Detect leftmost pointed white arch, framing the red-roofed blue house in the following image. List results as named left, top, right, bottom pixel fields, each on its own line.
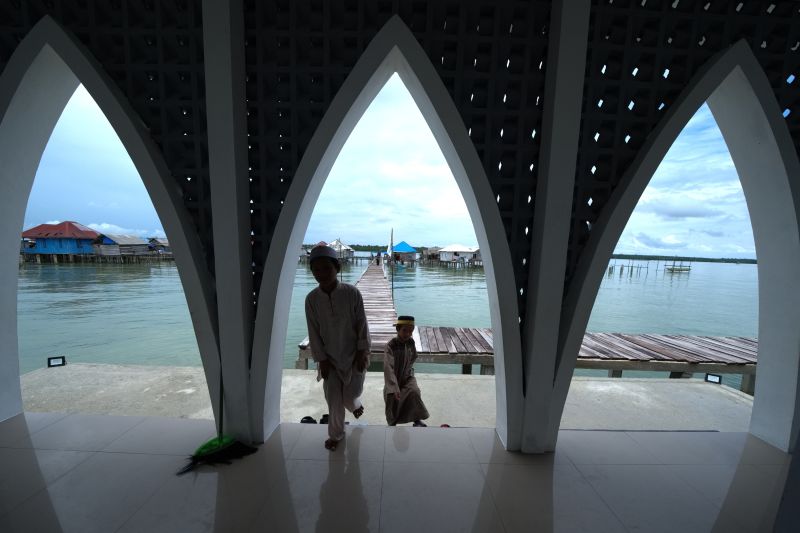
left=0, top=16, right=219, bottom=420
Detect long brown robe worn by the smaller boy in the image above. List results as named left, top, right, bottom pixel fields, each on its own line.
left=383, top=337, right=429, bottom=426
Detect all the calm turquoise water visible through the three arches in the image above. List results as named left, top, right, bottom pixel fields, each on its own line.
left=18, top=263, right=758, bottom=374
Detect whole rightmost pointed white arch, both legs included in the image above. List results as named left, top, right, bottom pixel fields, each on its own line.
left=549, top=41, right=800, bottom=450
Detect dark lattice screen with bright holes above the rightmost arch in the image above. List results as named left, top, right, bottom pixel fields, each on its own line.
left=567, top=0, right=800, bottom=283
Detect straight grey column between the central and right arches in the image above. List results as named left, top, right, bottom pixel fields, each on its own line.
left=522, top=0, right=590, bottom=453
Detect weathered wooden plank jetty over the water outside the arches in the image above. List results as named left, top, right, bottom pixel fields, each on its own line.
left=295, top=265, right=758, bottom=394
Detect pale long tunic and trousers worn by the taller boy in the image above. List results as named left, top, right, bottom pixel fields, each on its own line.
left=306, top=282, right=369, bottom=440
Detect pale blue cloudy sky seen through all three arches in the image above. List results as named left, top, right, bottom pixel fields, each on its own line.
left=24, top=75, right=755, bottom=257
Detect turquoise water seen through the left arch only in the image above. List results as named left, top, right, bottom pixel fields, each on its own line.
left=17, top=263, right=200, bottom=373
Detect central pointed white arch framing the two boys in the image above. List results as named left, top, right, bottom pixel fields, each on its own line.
left=251, top=16, right=522, bottom=449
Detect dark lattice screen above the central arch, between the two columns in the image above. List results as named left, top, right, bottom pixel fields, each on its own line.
left=245, top=0, right=550, bottom=324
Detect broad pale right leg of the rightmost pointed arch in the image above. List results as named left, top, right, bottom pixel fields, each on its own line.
left=708, top=64, right=800, bottom=451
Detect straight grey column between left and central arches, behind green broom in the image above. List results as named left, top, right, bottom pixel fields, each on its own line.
left=203, top=0, right=253, bottom=441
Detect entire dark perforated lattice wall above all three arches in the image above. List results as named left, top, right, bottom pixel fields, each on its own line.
left=9, top=0, right=800, bottom=336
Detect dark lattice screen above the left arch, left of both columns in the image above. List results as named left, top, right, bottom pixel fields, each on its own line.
left=0, top=0, right=214, bottom=272
